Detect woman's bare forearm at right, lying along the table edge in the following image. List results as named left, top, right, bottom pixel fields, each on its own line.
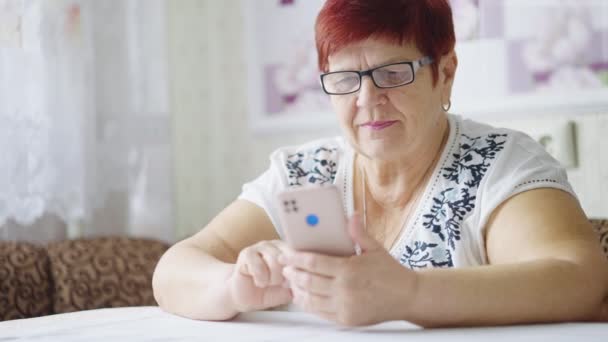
left=401, top=260, right=606, bottom=327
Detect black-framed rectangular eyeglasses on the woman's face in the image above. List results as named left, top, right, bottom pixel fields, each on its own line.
left=321, top=56, right=433, bottom=95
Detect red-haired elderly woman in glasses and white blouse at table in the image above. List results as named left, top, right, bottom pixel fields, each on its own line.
left=153, top=0, right=608, bottom=326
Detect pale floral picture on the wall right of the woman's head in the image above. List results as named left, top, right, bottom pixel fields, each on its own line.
left=451, top=0, right=608, bottom=117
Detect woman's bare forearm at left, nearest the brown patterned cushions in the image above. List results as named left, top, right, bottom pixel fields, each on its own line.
left=152, top=241, right=238, bottom=320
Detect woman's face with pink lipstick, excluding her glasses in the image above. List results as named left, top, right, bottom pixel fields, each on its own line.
left=329, top=39, right=457, bottom=160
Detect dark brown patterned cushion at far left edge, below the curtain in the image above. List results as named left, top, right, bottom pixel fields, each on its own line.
left=0, top=241, right=52, bottom=321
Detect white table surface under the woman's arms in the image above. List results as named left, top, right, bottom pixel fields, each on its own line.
left=0, top=307, right=608, bottom=342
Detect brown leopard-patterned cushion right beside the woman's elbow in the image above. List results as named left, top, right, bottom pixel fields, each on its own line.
left=47, top=237, right=168, bottom=313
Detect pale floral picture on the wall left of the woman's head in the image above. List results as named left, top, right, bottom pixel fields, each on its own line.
left=243, top=0, right=335, bottom=133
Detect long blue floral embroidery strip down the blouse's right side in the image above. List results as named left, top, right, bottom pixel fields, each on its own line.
left=400, top=134, right=507, bottom=268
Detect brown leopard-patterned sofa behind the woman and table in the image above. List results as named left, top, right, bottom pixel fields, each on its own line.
left=0, top=220, right=608, bottom=321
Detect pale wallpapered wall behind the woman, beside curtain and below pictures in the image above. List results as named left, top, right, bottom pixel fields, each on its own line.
left=167, top=0, right=608, bottom=237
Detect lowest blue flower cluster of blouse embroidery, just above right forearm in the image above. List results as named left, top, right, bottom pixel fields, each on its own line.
left=399, top=241, right=454, bottom=269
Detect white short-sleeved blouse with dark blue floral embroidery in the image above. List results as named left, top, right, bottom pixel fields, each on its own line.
left=239, top=115, right=576, bottom=269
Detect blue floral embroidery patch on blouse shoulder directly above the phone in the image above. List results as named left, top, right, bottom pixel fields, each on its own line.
left=286, top=147, right=338, bottom=186
